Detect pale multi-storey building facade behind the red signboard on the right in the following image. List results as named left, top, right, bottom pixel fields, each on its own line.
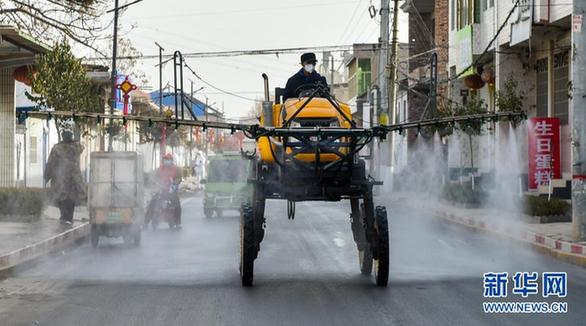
left=447, top=0, right=572, bottom=198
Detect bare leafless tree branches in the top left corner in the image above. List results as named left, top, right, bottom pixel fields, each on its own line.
left=0, top=0, right=110, bottom=56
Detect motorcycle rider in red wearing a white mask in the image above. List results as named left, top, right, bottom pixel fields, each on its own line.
left=145, top=153, right=181, bottom=228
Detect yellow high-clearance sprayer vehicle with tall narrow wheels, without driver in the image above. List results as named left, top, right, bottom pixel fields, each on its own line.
left=240, top=74, right=389, bottom=286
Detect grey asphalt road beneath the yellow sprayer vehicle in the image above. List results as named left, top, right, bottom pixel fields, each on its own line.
left=0, top=198, right=586, bottom=326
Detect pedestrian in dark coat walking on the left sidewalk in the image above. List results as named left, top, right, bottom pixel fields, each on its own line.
left=45, top=123, right=87, bottom=226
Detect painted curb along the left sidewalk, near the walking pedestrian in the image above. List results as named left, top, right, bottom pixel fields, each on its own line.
left=0, top=223, right=90, bottom=272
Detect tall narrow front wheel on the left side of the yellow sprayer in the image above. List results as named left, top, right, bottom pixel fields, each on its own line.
left=240, top=205, right=256, bottom=286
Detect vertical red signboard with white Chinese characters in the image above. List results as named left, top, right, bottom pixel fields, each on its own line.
left=528, top=118, right=562, bottom=189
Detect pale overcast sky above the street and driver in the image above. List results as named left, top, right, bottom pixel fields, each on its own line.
left=91, top=0, right=407, bottom=119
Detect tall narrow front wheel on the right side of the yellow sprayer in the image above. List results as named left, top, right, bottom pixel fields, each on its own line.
left=374, top=206, right=389, bottom=286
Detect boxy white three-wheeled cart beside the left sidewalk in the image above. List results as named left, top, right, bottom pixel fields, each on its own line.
left=88, top=152, right=144, bottom=248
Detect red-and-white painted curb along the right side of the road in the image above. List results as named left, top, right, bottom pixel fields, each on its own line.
left=435, top=211, right=586, bottom=267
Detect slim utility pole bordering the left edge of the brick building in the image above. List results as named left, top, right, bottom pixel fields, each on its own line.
left=387, top=0, right=399, bottom=166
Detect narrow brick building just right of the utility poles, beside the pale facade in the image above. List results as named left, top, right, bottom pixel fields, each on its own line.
left=393, top=0, right=449, bottom=173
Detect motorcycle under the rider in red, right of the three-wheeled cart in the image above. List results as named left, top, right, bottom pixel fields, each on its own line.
left=144, top=185, right=181, bottom=229
